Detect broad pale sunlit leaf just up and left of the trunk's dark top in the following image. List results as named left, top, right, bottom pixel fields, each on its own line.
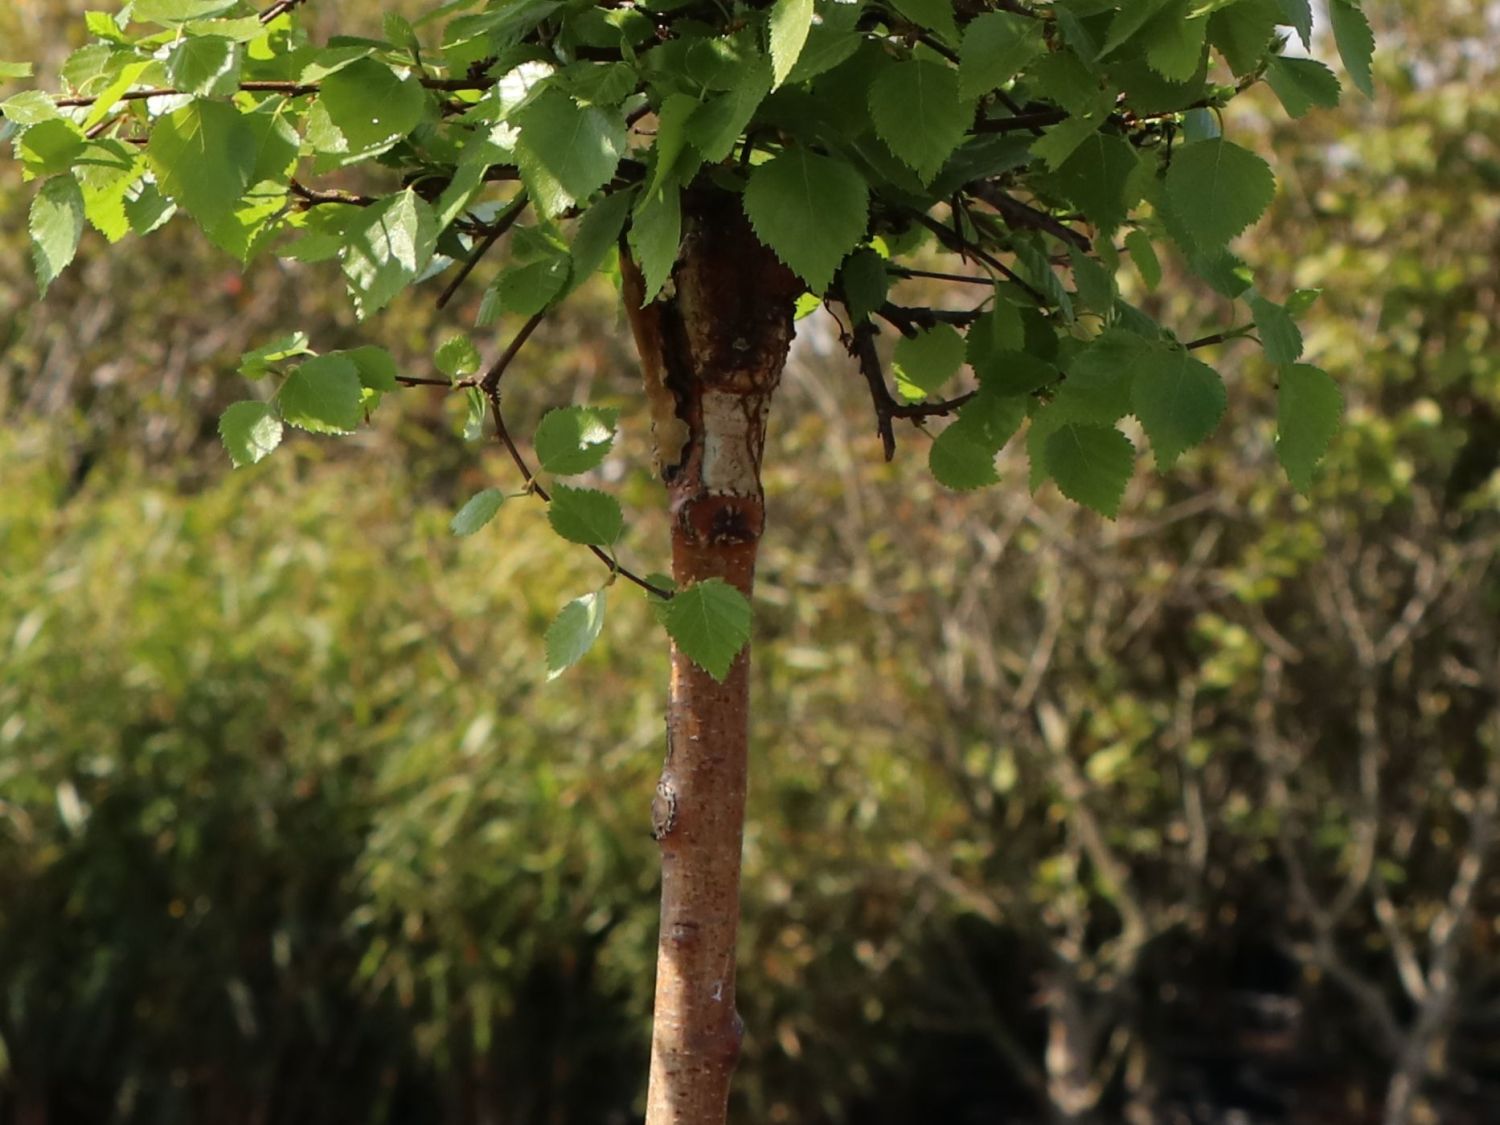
left=515, top=89, right=626, bottom=218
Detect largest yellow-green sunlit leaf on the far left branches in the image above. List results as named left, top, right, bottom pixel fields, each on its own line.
left=146, top=101, right=255, bottom=230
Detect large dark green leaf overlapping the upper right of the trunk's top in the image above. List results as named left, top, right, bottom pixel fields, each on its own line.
left=744, top=149, right=870, bottom=294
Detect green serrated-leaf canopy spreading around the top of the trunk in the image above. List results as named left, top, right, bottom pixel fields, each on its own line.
left=3, top=0, right=1371, bottom=669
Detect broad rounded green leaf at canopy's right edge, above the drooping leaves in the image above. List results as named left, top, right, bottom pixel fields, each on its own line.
left=1166, top=140, right=1277, bottom=249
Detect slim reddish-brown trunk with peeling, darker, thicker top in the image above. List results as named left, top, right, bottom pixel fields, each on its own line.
left=621, top=191, right=801, bottom=1125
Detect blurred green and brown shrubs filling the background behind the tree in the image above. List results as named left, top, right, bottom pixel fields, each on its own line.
left=0, top=0, right=1500, bottom=1125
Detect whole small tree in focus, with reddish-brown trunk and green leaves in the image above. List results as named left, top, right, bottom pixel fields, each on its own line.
left=0, top=0, right=1373, bottom=1125
